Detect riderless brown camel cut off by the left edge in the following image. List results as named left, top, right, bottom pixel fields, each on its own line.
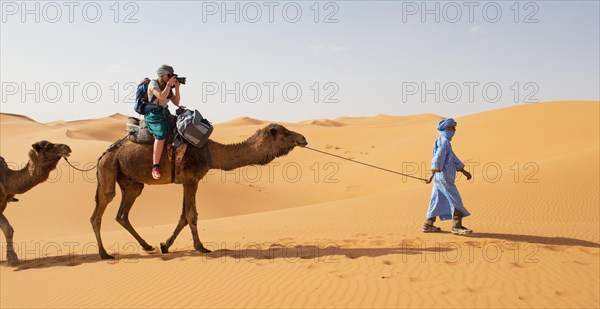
left=0, top=141, right=71, bottom=266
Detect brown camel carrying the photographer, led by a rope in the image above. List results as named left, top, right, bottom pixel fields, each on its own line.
left=90, top=124, right=308, bottom=259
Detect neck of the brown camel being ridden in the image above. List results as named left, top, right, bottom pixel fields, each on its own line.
left=208, top=140, right=275, bottom=171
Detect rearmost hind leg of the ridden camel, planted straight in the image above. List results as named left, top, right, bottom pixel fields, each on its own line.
left=90, top=157, right=117, bottom=259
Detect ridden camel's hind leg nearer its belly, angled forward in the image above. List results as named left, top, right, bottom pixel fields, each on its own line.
left=117, top=178, right=154, bottom=251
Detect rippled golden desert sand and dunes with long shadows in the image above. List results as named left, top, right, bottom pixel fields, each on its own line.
left=0, top=101, right=600, bottom=308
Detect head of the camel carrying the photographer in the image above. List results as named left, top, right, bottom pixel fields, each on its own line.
left=258, top=123, right=308, bottom=157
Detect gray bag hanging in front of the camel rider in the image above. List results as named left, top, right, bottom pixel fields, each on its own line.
left=177, top=109, right=213, bottom=148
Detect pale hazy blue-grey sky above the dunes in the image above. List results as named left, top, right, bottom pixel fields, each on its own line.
left=0, top=1, right=600, bottom=122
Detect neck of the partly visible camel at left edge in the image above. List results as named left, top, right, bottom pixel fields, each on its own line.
left=3, top=159, right=52, bottom=194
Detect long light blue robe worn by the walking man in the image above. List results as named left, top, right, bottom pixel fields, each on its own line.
left=427, top=132, right=470, bottom=220
